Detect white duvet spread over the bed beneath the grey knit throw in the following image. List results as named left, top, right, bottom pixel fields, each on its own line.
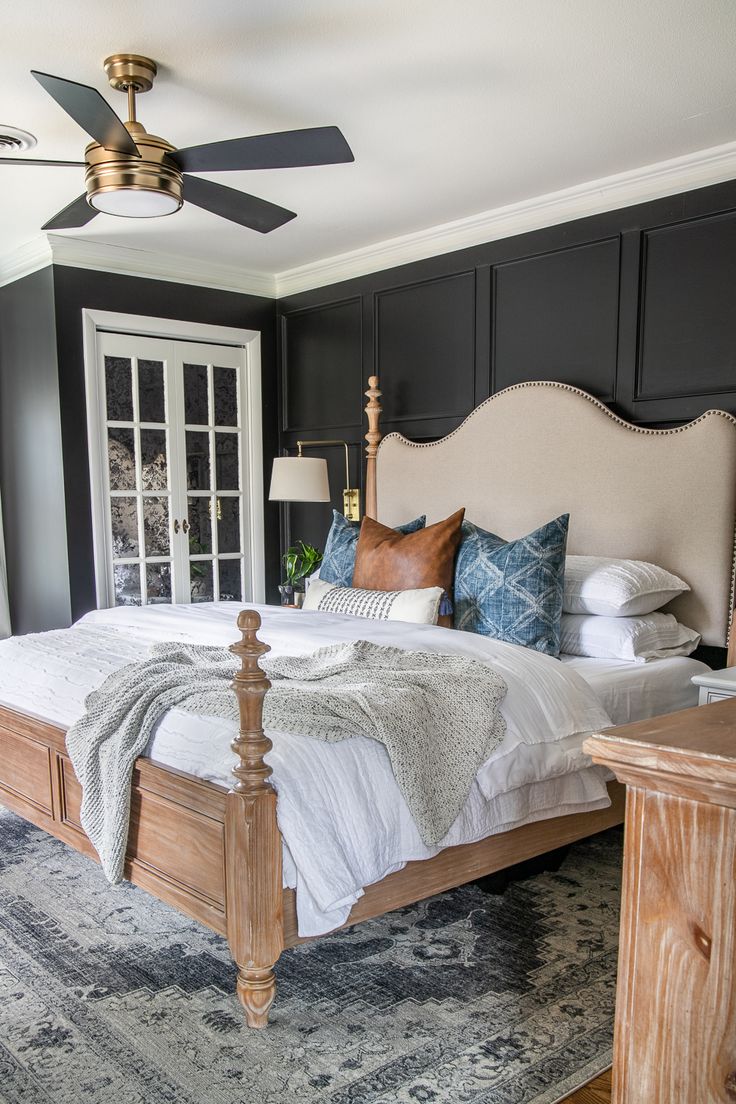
left=0, top=603, right=611, bottom=935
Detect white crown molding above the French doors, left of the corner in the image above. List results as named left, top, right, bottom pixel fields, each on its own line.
left=0, top=234, right=276, bottom=299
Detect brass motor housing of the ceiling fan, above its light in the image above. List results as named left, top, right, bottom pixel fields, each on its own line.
left=84, top=121, right=183, bottom=214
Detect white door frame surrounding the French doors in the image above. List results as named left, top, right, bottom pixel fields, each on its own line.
left=82, top=307, right=266, bottom=609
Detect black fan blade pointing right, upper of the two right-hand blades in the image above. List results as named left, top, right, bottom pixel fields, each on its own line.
left=174, top=127, right=355, bottom=172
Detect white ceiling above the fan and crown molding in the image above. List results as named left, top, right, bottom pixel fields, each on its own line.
left=0, top=0, right=736, bottom=293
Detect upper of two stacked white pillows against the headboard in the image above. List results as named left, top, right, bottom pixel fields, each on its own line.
left=563, top=555, right=690, bottom=617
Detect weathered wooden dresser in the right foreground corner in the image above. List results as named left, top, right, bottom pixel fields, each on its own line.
left=585, top=698, right=736, bottom=1104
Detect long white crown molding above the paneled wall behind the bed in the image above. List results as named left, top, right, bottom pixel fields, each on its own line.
left=276, top=142, right=736, bottom=298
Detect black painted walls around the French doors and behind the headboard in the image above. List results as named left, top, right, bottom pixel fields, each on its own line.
left=0, top=181, right=736, bottom=631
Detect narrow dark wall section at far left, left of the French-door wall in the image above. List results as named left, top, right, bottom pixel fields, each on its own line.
left=0, top=268, right=71, bottom=633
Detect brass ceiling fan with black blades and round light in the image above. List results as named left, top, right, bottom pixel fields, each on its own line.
left=0, top=54, right=355, bottom=234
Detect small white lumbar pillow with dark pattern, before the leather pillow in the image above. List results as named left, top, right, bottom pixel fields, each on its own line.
left=301, top=575, right=444, bottom=625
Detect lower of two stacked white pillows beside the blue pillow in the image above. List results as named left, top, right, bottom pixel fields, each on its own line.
left=559, top=614, right=701, bottom=664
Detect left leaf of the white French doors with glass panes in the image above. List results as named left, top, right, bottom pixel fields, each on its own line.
left=100, top=333, right=173, bottom=605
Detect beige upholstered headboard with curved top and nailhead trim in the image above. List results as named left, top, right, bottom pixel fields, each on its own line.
left=369, top=381, right=736, bottom=646
